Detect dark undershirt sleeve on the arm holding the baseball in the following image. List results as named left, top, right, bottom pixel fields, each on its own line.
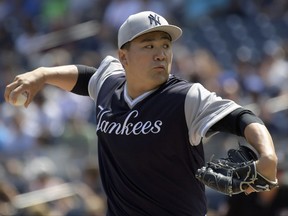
left=71, top=65, right=97, bottom=96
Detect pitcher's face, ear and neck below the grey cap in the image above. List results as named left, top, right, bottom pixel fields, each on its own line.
left=119, top=31, right=173, bottom=99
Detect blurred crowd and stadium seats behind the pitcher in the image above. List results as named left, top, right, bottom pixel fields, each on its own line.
left=0, top=0, right=288, bottom=216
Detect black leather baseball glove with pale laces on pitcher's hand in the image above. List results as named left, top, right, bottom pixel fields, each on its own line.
left=196, top=145, right=278, bottom=196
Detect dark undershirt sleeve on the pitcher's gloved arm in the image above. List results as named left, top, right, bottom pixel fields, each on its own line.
left=210, top=108, right=264, bottom=137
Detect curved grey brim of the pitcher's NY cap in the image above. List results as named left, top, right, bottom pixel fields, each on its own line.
left=130, top=25, right=182, bottom=41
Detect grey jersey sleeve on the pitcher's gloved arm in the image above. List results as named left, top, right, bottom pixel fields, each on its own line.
left=184, top=83, right=241, bottom=145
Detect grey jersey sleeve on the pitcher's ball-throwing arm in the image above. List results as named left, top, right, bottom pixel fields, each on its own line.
left=88, top=56, right=125, bottom=102
